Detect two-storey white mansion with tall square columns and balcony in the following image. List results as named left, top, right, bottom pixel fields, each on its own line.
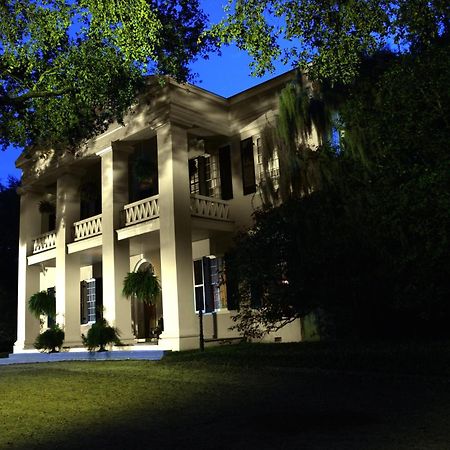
left=14, top=73, right=302, bottom=353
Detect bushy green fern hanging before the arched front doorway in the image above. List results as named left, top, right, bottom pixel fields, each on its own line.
left=122, top=265, right=161, bottom=304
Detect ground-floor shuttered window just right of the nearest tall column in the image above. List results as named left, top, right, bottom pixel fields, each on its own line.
left=194, top=256, right=227, bottom=313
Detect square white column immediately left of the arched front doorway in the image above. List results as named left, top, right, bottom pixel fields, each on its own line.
left=100, top=142, right=134, bottom=343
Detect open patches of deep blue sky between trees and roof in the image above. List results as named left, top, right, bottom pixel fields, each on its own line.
left=0, top=0, right=289, bottom=183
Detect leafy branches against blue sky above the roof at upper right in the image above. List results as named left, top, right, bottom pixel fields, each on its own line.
left=213, top=0, right=450, bottom=83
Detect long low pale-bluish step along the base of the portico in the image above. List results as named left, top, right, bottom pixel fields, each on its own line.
left=0, top=349, right=165, bottom=365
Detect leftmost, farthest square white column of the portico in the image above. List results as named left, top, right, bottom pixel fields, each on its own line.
left=14, top=192, right=41, bottom=353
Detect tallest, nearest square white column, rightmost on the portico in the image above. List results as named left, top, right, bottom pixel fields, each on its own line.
left=157, top=123, right=199, bottom=350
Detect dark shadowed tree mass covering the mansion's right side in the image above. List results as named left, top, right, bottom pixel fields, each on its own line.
left=228, top=38, right=450, bottom=337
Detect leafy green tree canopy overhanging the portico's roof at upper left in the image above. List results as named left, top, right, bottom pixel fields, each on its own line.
left=0, top=0, right=210, bottom=151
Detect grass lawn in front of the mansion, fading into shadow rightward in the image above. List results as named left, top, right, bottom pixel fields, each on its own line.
left=0, top=343, right=450, bottom=450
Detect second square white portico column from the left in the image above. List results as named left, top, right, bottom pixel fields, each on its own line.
left=55, top=174, right=82, bottom=347
